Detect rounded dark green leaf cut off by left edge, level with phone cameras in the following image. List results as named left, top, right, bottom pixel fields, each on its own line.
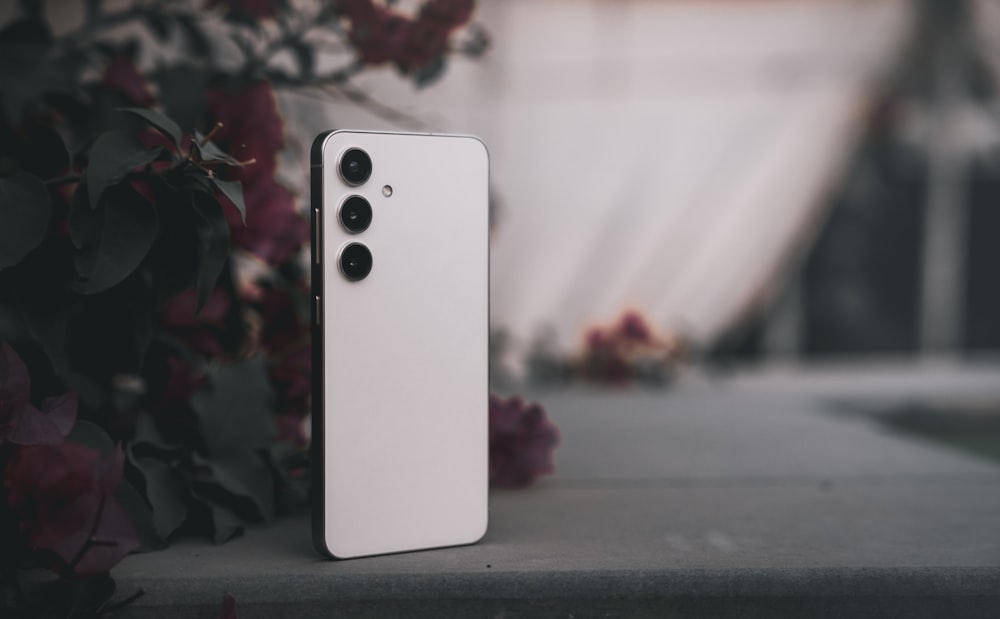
left=0, top=172, right=52, bottom=269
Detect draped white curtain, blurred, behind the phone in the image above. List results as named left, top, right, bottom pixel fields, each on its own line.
left=282, top=0, right=912, bottom=358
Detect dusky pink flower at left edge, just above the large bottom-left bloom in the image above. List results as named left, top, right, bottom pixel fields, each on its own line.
left=0, top=342, right=77, bottom=445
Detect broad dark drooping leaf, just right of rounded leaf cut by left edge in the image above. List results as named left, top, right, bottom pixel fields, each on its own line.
left=70, top=183, right=158, bottom=294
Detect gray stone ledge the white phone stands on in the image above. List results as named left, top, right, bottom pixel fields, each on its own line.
left=115, top=368, right=1000, bottom=619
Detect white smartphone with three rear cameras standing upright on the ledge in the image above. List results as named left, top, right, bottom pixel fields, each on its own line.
left=311, top=131, right=489, bottom=559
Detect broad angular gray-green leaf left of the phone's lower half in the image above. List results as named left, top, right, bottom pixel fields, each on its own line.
left=191, top=355, right=275, bottom=459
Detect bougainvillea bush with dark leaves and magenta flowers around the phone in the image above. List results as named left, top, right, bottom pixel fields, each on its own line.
left=0, top=0, right=554, bottom=617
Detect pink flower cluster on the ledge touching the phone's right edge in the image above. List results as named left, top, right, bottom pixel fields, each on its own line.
left=489, top=395, right=559, bottom=488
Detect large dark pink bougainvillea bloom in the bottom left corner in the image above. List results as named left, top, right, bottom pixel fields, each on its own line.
left=4, top=442, right=139, bottom=574
